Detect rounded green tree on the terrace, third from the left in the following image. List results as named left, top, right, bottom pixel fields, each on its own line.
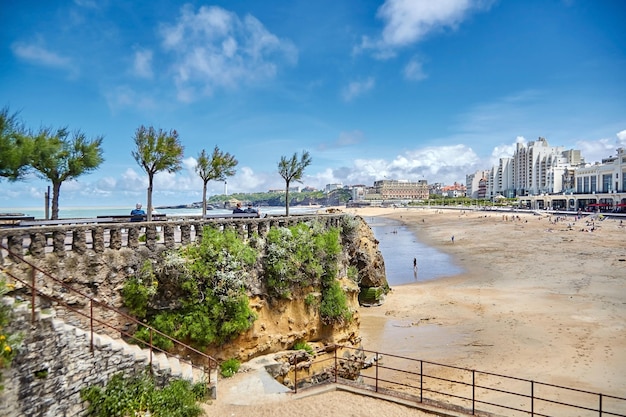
left=132, top=125, right=184, bottom=221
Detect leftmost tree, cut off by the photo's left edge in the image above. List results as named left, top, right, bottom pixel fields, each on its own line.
left=0, top=107, right=33, bottom=181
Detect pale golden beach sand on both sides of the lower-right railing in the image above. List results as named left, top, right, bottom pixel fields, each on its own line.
left=202, top=208, right=626, bottom=417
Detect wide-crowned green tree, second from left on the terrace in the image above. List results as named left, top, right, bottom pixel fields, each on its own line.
left=30, top=128, right=104, bottom=220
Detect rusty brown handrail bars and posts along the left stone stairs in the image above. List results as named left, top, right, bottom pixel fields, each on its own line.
left=0, top=244, right=218, bottom=383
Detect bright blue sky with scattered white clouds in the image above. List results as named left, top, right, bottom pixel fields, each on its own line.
left=0, top=0, right=626, bottom=208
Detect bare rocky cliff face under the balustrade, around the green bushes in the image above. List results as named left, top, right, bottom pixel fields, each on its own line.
left=4, top=217, right=388, bottom=361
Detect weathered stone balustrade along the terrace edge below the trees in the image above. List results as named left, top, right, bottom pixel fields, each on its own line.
left=0, top=214, right=345, bottom=261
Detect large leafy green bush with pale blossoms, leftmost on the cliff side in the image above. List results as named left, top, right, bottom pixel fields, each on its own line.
left=122, top=227, right=257, bottom=349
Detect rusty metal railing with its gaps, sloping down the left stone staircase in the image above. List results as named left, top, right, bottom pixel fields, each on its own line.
left=0, top=244, right=218, bottom=384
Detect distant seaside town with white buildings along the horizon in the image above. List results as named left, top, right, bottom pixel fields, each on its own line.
left=166, top=137, right=626, bottom=212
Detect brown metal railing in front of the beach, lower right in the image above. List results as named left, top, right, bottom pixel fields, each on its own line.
left=294, top=346, right=626, bottom=417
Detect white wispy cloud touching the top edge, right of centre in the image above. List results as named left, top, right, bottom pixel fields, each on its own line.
left=356, top=0, right=491, bottom=59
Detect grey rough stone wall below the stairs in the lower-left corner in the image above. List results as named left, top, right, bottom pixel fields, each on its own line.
left=0, top=298, right=193, bottom=417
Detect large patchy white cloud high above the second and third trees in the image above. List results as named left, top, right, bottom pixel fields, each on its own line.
left=160, top=5, right=298, bottom=102
